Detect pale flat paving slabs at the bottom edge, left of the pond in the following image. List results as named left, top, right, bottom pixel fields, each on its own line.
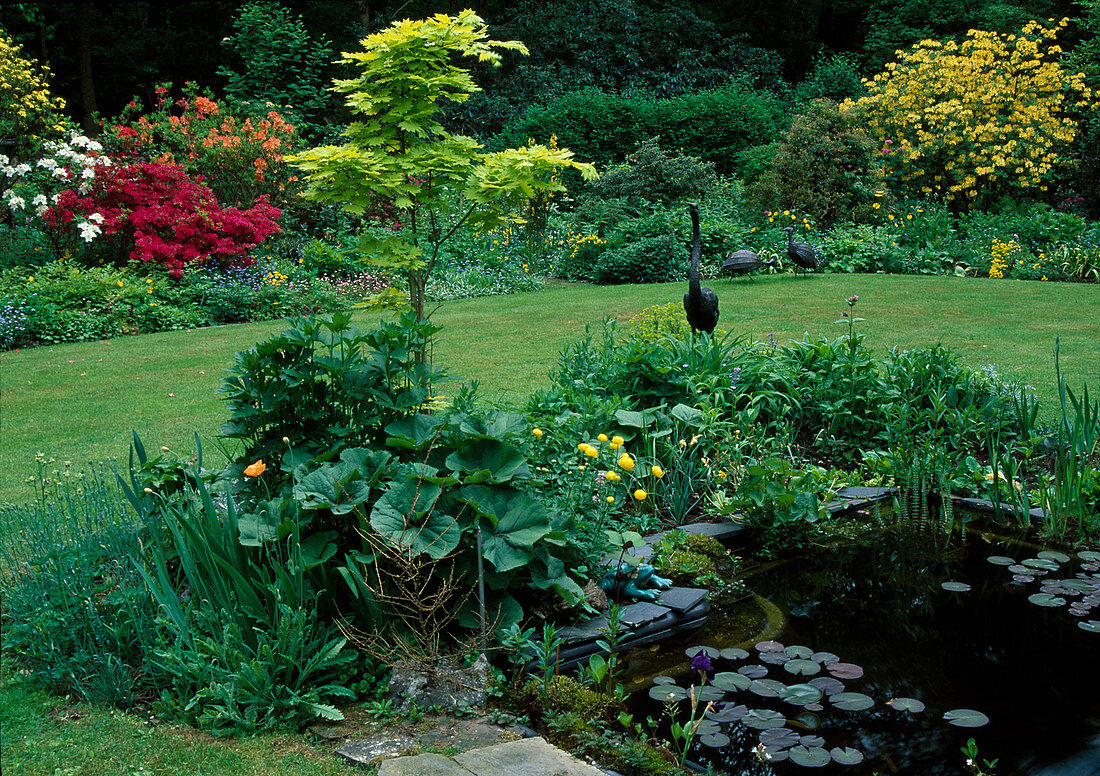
left=378, top=739, right=604, bottom=776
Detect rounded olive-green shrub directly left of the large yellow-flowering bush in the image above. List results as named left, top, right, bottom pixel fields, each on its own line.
left=746, top=100, right=889, bottom=225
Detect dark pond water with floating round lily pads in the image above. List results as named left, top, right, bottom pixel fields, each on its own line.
left=647, top=526, right=1100, bottom=776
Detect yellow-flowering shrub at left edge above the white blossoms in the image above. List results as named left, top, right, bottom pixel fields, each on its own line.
left=0, top=32, right=65, bottom=151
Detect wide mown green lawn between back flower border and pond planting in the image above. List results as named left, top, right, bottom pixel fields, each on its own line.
left=0, top=275, right=1100, bottom=502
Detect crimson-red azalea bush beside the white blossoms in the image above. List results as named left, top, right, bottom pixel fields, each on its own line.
left=43, top=162, right=282, bottom=278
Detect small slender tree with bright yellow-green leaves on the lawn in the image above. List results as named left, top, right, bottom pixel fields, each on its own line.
left=283, top=11, right=596, bottom=320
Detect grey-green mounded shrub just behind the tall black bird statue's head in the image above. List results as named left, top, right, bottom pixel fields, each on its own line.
left=590, top=138, right=717, bottom=207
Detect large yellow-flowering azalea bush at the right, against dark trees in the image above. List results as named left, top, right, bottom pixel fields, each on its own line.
left=843, top=19, right=1092, bottom=208
